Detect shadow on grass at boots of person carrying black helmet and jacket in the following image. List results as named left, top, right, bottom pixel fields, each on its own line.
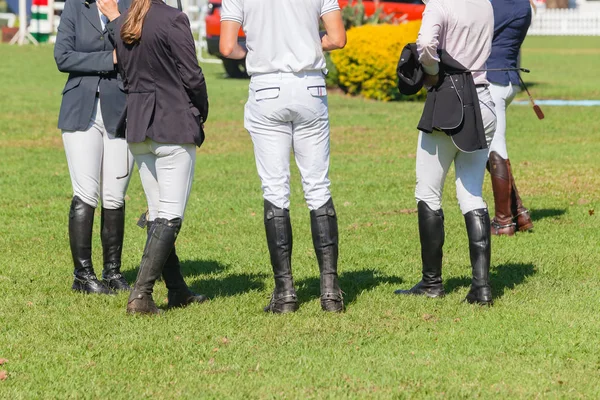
left=444, top=263, right=536, bottom=298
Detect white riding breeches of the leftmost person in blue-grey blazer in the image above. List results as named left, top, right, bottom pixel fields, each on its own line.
left=62, top=99, right=133, bottom=210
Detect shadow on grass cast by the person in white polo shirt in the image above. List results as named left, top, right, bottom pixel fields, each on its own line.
left=296, top=269, right=402, bottom=306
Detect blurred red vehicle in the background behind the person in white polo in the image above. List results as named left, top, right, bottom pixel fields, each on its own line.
left=206, top=0, right=425, bottom=78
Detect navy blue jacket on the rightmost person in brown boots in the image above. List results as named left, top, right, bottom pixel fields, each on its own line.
left=486, top=0, right=531, bottom=86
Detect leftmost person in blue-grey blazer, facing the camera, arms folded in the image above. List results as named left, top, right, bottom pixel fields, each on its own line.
left=54, top=0, right=133, bottom=294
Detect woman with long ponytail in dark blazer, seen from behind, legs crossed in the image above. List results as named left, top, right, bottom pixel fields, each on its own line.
left=103, top=0, right=208, bottom=314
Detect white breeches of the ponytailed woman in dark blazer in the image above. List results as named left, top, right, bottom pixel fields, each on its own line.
left=129, top=139, right=196, bottom=221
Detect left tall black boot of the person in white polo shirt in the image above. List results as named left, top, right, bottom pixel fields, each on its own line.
left=264, top=200, right=298, bottom=314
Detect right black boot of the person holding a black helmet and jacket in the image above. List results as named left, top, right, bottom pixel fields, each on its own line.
left=465, top=208, right=493, bottom=305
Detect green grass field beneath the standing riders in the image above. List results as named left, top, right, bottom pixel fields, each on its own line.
left=0, top=37, right=600, bottom=399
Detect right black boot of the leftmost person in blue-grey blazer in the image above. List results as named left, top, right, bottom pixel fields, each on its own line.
left=100, top=206, right=131, bottom=291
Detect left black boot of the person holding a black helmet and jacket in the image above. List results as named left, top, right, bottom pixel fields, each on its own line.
left=394, top=201, right=445, bottom=297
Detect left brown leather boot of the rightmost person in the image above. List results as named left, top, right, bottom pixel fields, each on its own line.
left=488, top=151, right=516, bottom=236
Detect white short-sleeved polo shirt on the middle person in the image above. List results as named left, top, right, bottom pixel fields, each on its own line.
left=221, top=0, right=340, bottom=75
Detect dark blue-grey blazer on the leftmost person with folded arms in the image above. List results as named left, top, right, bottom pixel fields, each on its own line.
left=54, top=0, right=131, bottom=134
